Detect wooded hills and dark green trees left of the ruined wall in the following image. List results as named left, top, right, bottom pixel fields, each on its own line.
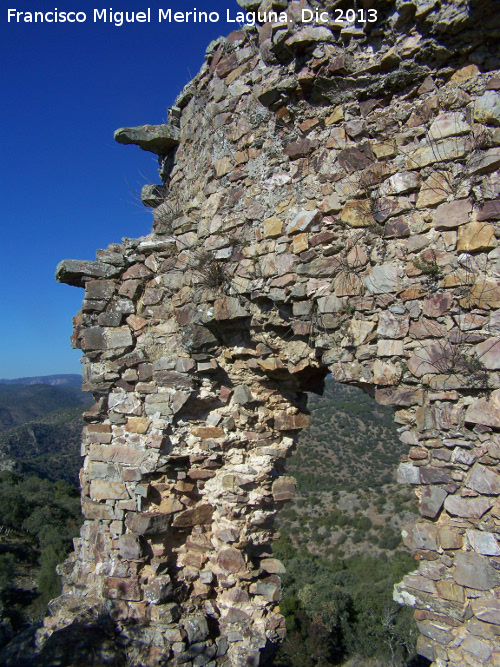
left=0, top=376, right=86, bottom=652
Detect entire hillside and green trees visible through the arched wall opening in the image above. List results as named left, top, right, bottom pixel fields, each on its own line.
left=271, top=379, right=422, bottom=667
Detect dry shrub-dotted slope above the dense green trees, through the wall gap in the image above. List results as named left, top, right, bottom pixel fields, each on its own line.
left=278, top=379, right=417, bottom=557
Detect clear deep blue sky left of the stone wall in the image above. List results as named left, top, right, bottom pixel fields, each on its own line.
left=0, top=0, right=241, bottom=378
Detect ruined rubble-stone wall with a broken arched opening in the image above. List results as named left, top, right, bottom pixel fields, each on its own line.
left=39, top=2, right=500, bottom=666
